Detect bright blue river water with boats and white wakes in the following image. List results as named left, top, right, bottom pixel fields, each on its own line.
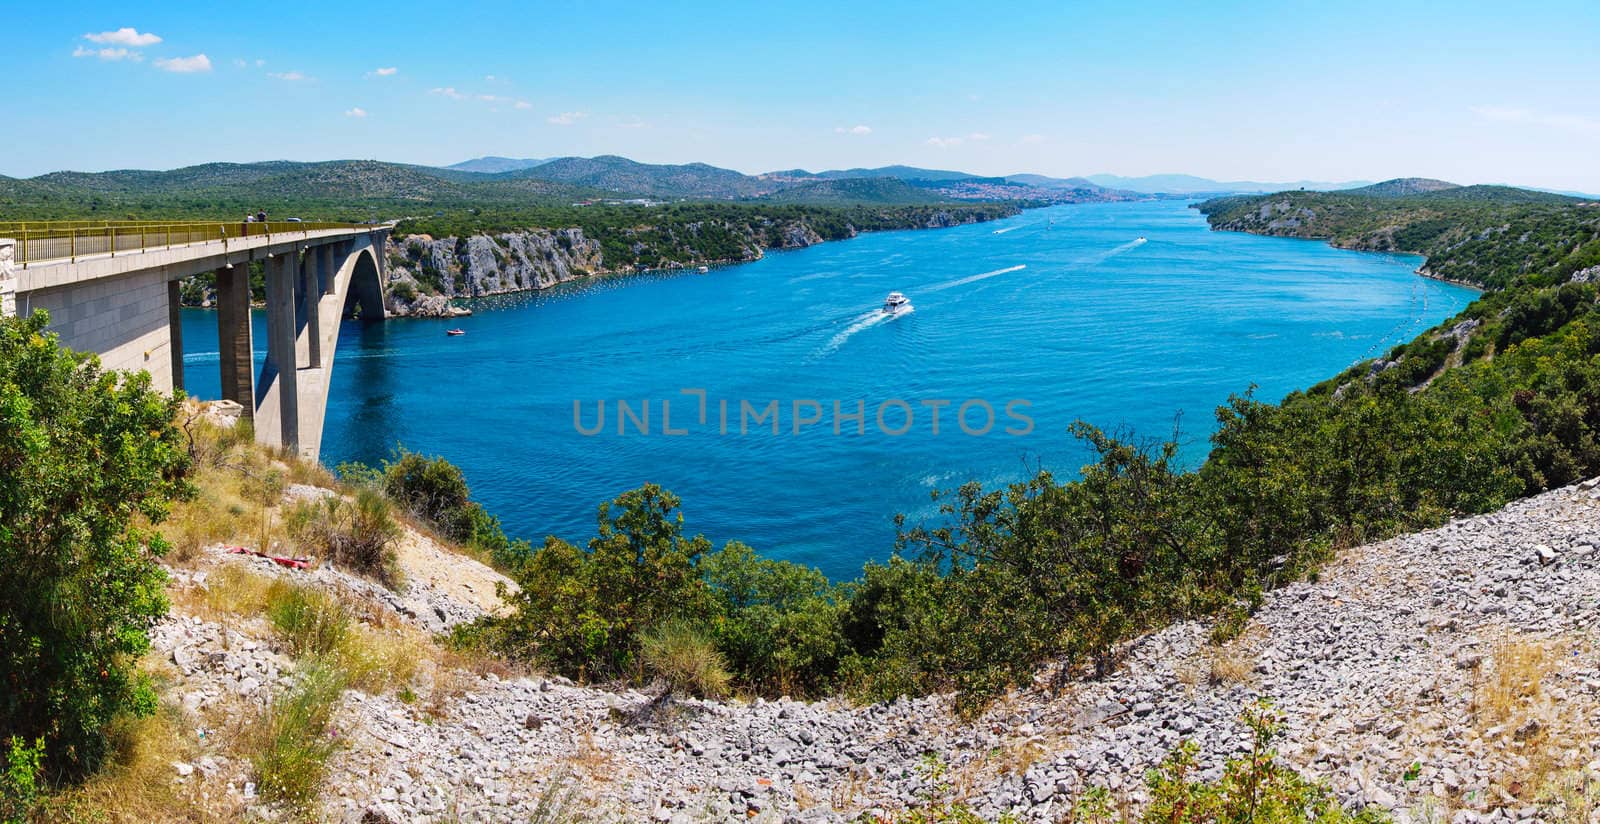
left=184, top=202, right=1475, bottom=579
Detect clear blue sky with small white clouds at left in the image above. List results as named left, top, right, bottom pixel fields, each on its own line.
left=9, top=0, right=1600, bottom=192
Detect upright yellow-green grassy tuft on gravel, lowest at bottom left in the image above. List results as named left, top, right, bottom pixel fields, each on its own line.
left=250, top=659, right=344, bottom=811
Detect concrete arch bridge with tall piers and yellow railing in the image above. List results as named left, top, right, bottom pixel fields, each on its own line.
left=0, top=221, right=394, bottom=459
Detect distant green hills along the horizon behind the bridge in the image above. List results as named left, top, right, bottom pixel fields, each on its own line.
left=0, top=155, right=1141, bottom=222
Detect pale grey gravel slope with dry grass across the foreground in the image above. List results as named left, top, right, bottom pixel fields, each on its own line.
left=157, top=482, right=1600, bottom=824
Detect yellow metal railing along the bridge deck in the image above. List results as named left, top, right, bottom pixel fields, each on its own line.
left=0, top=221, right=376, bottom=269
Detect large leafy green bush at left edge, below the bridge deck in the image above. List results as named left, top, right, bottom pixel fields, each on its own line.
left=0, top=312, right=190, bottom=778
